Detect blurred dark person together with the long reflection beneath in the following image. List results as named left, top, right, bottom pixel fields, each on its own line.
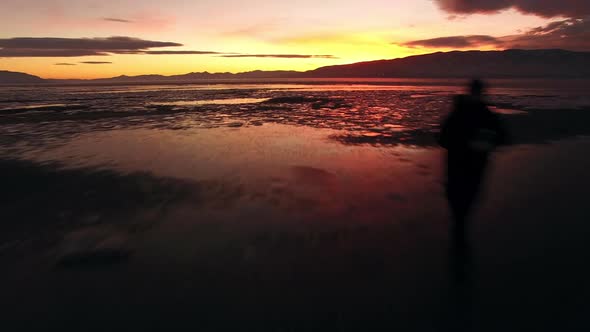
left=439, top=80, right=507, bottom=331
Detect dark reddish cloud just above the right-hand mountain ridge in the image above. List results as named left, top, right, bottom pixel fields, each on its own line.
left=400, top=18, right=590, bottom=51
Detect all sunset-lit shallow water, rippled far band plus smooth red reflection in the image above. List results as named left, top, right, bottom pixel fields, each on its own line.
left=0, top=81, right=590, bottom=231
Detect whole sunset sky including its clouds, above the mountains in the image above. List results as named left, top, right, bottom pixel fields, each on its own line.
left=0, top=0, right=590, bottom=79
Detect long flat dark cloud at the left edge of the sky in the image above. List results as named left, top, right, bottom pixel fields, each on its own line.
left=0, top=37, right=182, bottom=57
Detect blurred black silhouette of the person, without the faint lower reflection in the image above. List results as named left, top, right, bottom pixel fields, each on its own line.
left=439, top=80, right=506, bottom=255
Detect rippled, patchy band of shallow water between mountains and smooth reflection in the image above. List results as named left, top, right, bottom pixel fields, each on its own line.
left=0, top=80, right=590, bottom=158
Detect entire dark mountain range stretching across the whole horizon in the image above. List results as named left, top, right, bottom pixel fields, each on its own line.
left=0, top=49, right=590, bottom=84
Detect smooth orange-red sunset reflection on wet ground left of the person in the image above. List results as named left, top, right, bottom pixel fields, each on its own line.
left=19, top=124, right=442, bottom=227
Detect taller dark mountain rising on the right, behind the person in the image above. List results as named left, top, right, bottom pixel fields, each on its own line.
left=305, top=50, right=590, bottom=78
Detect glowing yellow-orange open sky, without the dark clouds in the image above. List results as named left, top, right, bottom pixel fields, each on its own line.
left=0, top=0, right=563, bottom=78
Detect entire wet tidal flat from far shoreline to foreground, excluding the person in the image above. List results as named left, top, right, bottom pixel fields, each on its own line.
left=0, top=80, right=590, bottom=331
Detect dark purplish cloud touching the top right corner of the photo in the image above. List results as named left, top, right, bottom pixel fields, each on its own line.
left=435, top=0, right=590, bottom=18
